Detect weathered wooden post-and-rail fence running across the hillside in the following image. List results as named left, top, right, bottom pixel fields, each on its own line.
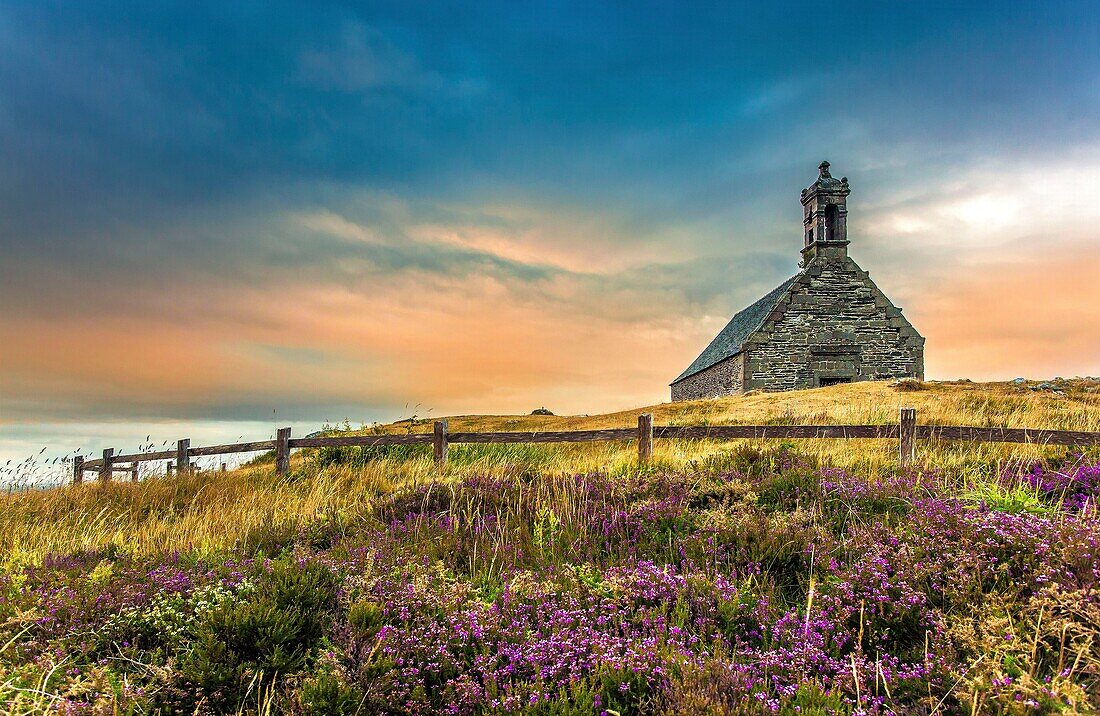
left=73, top=408, right=1100, bottom=483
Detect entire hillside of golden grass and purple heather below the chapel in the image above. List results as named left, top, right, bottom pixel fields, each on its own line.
left=0, top=381, right=1100, bottom=715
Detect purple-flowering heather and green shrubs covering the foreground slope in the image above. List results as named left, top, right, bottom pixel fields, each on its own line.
left=0, top=458, right=1100, bottom=715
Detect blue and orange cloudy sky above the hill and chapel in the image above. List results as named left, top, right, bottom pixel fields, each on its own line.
left=0, top=0, right=1100, bottom=475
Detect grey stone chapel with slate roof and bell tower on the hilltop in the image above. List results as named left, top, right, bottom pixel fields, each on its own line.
left=671, top=162, right=924, bottom=400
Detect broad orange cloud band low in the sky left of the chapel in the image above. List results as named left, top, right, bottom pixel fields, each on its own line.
left=0, top=265, right=699, bottom=415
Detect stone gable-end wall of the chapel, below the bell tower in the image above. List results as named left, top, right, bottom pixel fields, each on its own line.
left=743, top=257, right=924, bottom=391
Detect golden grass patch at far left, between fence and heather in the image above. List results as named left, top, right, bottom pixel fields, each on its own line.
left=0, top=464, right=393, bottom=563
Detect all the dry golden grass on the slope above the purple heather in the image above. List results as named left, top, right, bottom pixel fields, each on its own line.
left=0, top=382, right=1100, bottom=566
